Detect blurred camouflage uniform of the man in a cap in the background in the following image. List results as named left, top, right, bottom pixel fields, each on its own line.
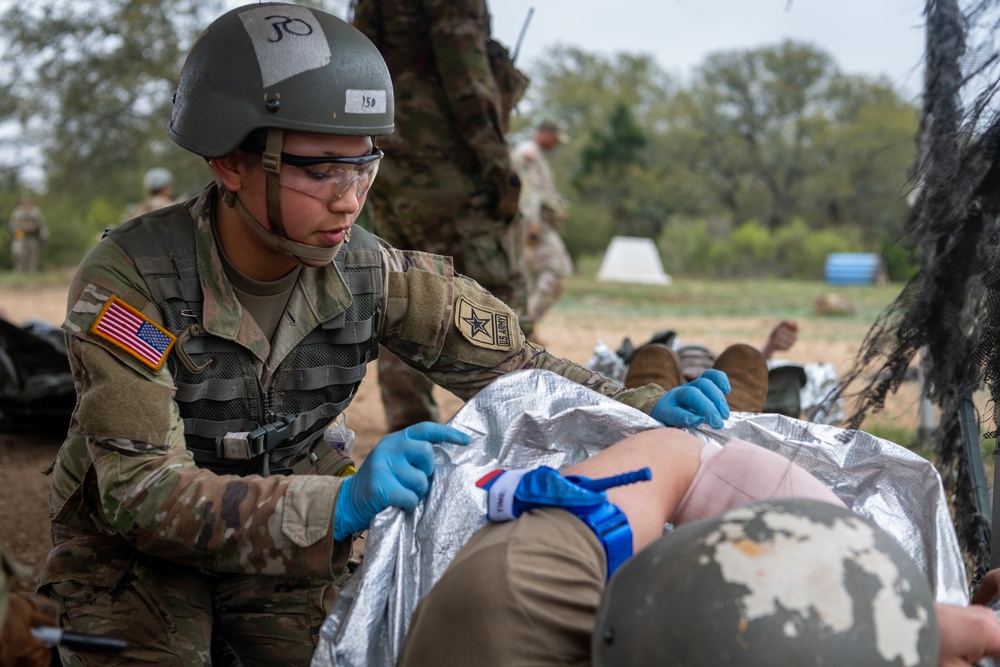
left=511, top=139, right=573, bottom=324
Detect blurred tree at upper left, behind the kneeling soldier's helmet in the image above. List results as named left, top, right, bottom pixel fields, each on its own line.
left=0, top=0, right=222, bottom=201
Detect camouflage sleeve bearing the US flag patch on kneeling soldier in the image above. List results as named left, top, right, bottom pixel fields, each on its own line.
left=60, top=240, right=350, bottom=577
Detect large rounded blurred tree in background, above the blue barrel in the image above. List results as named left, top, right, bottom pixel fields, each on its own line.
left=669, top=41, right=917, bottom=233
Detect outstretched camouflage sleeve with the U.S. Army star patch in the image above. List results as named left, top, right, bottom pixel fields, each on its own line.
left=380, top=247, right=665, bottom=414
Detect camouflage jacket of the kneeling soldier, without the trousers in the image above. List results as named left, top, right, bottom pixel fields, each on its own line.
left=40, top=186, right=662, bottom=583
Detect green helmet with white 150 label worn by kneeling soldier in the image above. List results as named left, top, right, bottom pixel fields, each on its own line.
left=169, top=3, right=393, bottom=158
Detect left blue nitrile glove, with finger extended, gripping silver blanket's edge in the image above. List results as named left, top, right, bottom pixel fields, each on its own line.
left=333, top=422, right=472, bottom=541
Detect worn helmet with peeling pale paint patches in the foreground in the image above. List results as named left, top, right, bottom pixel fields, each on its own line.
left=593, top=499, right=939, bottom=667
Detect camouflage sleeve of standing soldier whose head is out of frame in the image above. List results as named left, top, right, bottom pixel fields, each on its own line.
left=424, top=0, right=511, bottom=173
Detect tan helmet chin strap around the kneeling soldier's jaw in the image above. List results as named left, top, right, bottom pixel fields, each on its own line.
left=214, top=128, right=342, bottom=266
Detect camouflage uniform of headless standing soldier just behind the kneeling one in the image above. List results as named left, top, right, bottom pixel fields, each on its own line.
left=354, top=0, right=530, bottom=431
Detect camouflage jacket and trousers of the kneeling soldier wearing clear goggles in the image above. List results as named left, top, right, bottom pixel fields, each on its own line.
left=39, top=185, right=663, bottom=665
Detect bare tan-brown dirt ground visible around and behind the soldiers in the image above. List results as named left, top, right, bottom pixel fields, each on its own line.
left=0, top=276, right=916, bottom=589
